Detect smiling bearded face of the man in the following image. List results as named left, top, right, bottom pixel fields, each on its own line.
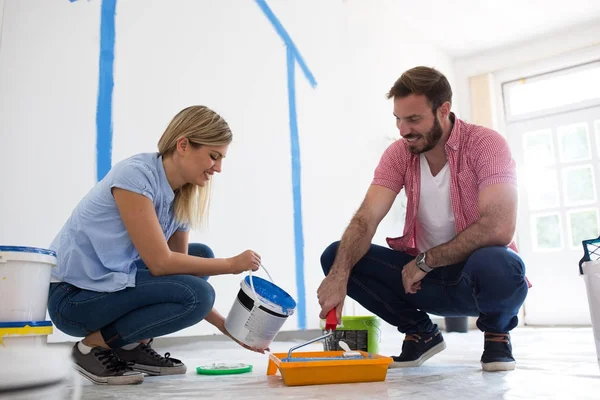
left=394, top=94, right=443, bottom=154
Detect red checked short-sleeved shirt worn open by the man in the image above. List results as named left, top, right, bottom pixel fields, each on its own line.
left=372, top=114, right=517, bottom=256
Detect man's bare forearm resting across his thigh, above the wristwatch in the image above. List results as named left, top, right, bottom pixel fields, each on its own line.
left=425, top=218, right=508, bottom=268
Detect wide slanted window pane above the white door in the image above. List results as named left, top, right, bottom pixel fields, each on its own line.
left=506, top=63, right=600, bottom=116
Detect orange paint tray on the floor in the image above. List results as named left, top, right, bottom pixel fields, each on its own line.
left=267, top=351, right=393, bottom=386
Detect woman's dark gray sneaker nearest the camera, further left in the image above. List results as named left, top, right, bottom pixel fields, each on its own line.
left=72, top=343, right=144, bottom=385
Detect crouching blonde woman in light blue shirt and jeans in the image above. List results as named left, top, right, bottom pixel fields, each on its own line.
left=48, top=106, right=262, bottom=384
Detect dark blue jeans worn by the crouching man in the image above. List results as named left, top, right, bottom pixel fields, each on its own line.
left=321, top=242, right=528, bottom=333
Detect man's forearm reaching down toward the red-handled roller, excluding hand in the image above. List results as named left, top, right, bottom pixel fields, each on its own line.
left=330, top=213, right=375, bottom=276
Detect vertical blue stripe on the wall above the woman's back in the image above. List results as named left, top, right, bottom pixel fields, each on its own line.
left=96, top=0, right=117, bottom=181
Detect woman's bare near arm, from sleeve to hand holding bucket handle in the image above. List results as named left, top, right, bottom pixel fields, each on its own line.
left=112, top=188, right=260, bottom=276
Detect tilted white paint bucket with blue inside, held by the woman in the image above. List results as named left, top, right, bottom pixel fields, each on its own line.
left=225, top=268, right=296, bottom=350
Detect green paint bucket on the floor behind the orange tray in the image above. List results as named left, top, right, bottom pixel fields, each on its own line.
left=321, top=315, right=381, bottom=354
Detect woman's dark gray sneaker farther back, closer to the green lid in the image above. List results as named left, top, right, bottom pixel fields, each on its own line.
left=115, top=340, right=187, bottom=376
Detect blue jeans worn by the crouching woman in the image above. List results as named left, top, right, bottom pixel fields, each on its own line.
left=48, top=243, right=215, bottom=348
